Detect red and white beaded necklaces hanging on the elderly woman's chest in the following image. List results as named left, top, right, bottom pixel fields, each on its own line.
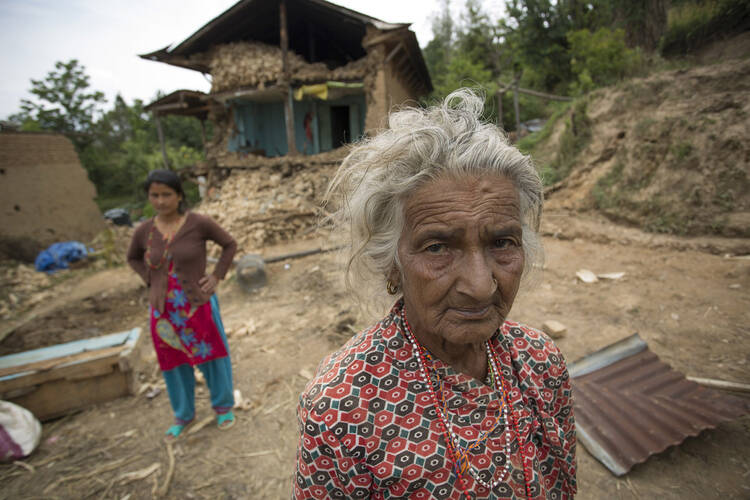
left=401, top=307, right=530, bottom=498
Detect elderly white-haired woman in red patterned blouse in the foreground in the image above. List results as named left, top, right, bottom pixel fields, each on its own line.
left=293, top=90, right=576, bottom=499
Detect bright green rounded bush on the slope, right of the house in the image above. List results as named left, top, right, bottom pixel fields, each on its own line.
left=567, top=28, right=641, bottom=93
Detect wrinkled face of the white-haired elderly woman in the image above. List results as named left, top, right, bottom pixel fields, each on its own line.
left=392, top=176, right=524, bottom=344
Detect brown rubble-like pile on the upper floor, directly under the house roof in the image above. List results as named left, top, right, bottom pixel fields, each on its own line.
left=205, top=42, right=373, bottom=93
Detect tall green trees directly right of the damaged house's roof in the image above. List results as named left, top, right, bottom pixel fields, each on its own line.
left=424, top=0, right=666, bottom=130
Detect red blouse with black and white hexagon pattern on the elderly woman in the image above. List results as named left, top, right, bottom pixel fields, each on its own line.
left=293, top=302, right=576, bottom=499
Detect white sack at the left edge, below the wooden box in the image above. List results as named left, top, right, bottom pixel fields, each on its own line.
left=0, top=400, right=42, bottom=462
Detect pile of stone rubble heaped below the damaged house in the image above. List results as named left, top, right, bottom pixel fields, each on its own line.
left=198, top=154, right=345, bottom=257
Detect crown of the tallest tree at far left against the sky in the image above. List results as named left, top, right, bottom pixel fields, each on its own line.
left=11, top=59, right=106, bottom=148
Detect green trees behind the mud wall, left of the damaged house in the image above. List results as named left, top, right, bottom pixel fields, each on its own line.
left=10, top=59, right=210, bottom=210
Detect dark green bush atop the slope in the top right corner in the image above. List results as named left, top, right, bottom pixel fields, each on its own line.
left=660, top=0, right=750, bottom=56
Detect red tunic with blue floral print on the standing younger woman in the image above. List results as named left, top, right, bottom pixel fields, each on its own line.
left=150, top=261, right=227, bottom=370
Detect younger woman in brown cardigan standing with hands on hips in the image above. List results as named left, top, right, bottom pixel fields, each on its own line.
left=127, top=170, right=237, bottom=439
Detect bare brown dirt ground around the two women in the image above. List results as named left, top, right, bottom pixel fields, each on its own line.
left=0, top=212, right=750, bottom=499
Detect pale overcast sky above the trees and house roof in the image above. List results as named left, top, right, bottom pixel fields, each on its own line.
left=0, top=0, right=503, bottom=119
